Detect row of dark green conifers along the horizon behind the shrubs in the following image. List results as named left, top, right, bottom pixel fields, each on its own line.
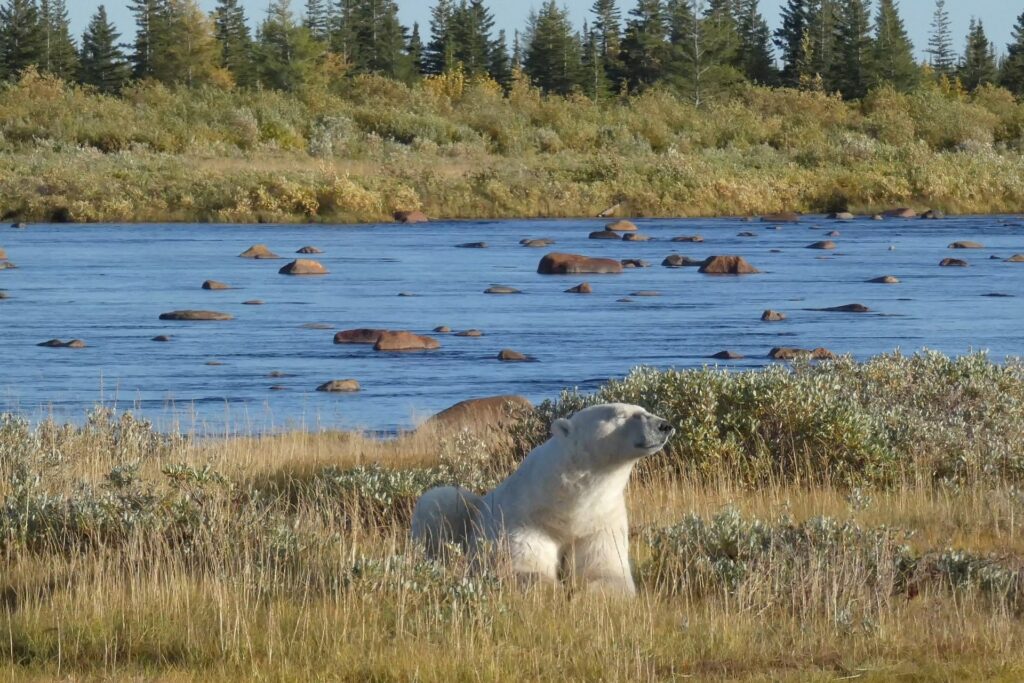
left=6, top=0, right=1024, bottom=103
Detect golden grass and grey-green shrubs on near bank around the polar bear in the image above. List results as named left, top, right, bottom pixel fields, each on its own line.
left=0, top=354, right=1024, bottom=681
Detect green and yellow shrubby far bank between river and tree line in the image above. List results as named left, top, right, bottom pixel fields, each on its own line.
left=0, top=72, right=1024, bottom=223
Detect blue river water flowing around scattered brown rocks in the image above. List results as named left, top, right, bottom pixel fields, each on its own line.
left=0, top=216, right=1024, bottom=431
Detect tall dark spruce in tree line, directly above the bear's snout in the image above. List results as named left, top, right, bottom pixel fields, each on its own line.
left=621, top=0, right=671, bottom=90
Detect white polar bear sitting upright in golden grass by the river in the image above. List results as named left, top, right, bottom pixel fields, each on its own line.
left=412, top=403, right=675, bottom=595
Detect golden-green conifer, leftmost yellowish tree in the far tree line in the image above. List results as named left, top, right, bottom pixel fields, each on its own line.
left=153, top=0, right=220, bottom=87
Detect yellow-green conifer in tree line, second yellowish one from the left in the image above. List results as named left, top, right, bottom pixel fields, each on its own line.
left=255, top=0, right=322, bottom=91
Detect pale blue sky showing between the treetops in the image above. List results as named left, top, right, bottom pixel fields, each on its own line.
left=68, top=0, right=1024, bottom=60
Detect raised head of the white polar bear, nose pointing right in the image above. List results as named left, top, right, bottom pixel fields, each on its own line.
left=551, top=403, right=676, bottom=465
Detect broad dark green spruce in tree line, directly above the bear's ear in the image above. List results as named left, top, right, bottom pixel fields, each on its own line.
left=523, top=0, right=583, bottom=95
